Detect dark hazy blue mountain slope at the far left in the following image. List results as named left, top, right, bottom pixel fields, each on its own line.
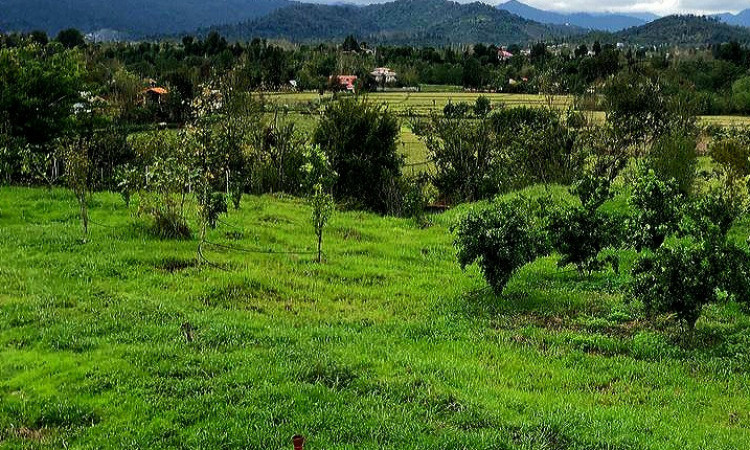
left=0, top=0, right=292, bottom=36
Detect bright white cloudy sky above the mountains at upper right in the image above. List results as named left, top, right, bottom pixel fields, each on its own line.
left=318, top=0, right=750, bottom=15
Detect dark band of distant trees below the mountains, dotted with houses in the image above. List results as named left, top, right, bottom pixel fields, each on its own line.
left=0, top=30, right=750, bottom=116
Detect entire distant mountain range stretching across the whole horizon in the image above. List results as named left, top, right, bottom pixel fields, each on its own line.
left=0, top=0, right=750, bottom=46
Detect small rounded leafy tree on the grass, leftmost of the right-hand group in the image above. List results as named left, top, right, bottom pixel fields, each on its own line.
left=453, top=198, right=544, bottom=294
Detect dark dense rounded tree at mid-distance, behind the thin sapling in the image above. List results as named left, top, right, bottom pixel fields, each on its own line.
left=313, top=98, right=403, bottom=213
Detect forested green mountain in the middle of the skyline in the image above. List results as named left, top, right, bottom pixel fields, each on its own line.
left=212, top=0, right=585, bottom=45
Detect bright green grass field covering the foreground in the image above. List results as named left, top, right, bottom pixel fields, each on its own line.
left=0, top=188, right=750, bottom=450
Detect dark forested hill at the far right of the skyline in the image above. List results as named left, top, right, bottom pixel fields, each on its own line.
left=614, top=15, right=750, bottom=45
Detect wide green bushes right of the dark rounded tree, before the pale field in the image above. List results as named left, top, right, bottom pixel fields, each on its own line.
left=412, top=103, right=585, bottom=202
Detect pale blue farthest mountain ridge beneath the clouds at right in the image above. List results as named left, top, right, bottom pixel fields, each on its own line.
left=497, top=0, right=657, bottom=31
